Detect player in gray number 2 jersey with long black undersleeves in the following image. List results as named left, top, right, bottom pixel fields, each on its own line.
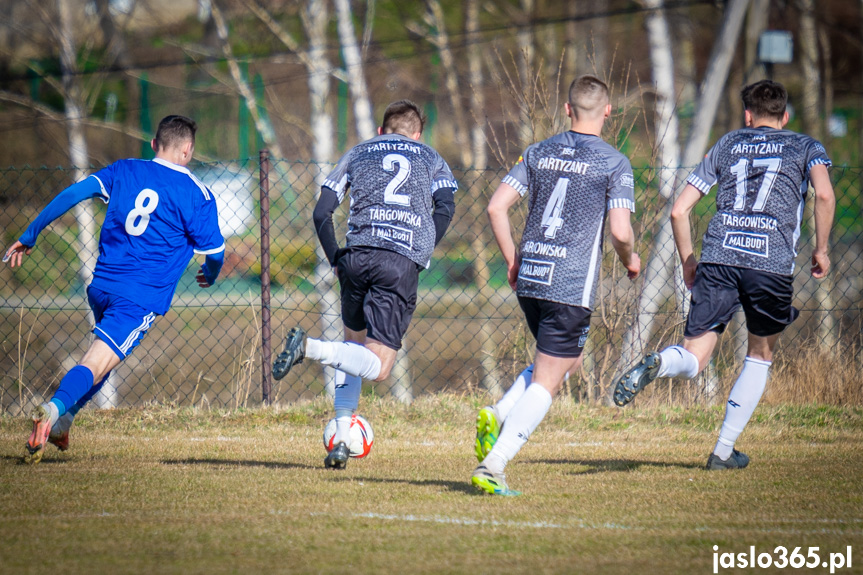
left=273, top=100, right=458, bottom=469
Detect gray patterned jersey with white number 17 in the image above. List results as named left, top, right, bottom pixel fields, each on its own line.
left=686, top=127, right=830, bottom=275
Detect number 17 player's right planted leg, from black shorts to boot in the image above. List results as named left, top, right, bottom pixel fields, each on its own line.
left=707, top=270, right=798, bottom=469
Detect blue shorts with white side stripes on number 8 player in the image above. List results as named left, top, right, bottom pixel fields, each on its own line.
left=87, top=286, right=156, bottom=359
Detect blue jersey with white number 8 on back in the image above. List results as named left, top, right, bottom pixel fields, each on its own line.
left=90, top=158, right=225, bottom=315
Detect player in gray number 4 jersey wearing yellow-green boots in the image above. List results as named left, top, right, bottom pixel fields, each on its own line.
left=471, top=76, right=641, bottom=495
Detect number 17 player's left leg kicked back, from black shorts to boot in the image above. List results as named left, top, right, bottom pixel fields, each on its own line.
left=613, top=264, right=740, bottom=406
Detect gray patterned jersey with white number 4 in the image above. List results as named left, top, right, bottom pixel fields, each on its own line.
left=503, top=132, right=635, bottom=309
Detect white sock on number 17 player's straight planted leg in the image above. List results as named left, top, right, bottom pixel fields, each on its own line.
left=713, top=357, right=771, bottom=459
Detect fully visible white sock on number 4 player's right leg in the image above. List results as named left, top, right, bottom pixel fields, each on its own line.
left=482, top=385, right=551, bottom=473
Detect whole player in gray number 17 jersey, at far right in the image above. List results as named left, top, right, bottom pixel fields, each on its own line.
left=614, top=80, right=836, bottom=469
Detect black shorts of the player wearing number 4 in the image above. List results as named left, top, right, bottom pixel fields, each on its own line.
left=518, top=296, right=590, bottom=357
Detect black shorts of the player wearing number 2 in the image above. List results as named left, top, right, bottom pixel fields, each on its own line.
left=336, top=247, right=419, bottom=349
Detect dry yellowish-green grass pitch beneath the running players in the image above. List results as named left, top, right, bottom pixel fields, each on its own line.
left=0, top=395, right=863, bottom=575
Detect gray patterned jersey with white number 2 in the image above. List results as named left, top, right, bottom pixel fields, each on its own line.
left=324, top=134, right=458, bottom=267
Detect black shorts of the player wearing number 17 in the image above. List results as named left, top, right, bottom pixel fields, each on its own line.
left=683, top=263, right=800, bottom=337
